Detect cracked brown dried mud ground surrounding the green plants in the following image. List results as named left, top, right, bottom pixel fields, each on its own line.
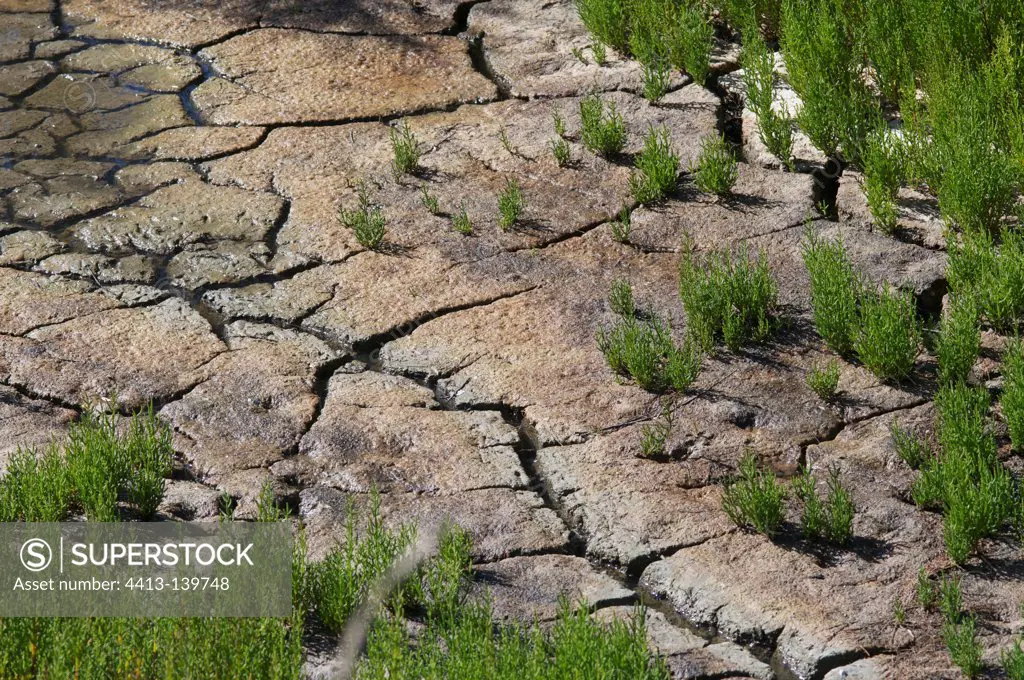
left=0, top=0, right=1024, bottom=679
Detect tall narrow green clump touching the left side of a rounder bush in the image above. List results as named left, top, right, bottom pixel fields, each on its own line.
left=802, top=227, right=861, bottom=356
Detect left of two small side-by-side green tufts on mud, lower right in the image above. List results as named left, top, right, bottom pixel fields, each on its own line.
left=722, top=453, right=786, bottom=538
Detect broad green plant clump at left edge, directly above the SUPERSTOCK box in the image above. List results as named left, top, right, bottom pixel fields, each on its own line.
left=0, top=409, right=173, bottom=522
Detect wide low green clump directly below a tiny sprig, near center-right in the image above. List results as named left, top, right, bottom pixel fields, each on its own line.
left=597, top=314, right=702, bottom=392
